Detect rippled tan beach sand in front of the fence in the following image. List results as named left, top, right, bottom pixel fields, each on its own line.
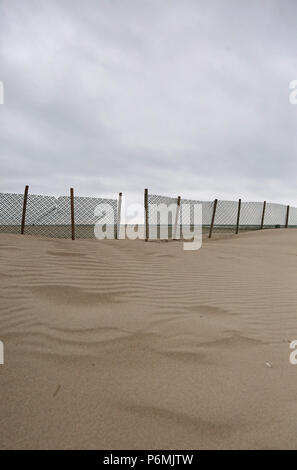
left=0, top=229, right=297, bottom=449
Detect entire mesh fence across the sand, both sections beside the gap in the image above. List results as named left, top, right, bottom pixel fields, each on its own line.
left=0, top=187, right=297, bottom=240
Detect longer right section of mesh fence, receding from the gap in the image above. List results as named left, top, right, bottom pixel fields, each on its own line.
left=145, top=194, right=297, bottom=239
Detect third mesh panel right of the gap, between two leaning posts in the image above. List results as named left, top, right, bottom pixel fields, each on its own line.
left=212, top=200, right=238, bottom=235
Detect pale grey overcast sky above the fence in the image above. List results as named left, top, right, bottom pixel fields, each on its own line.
left=0, top=0, right=297, bottom=205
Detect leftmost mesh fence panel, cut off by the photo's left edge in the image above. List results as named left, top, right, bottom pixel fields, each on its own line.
left=0, top=193, right=24, bottom=233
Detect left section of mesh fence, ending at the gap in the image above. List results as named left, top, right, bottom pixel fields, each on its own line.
left=0, top=192, right=118, bottom=238
